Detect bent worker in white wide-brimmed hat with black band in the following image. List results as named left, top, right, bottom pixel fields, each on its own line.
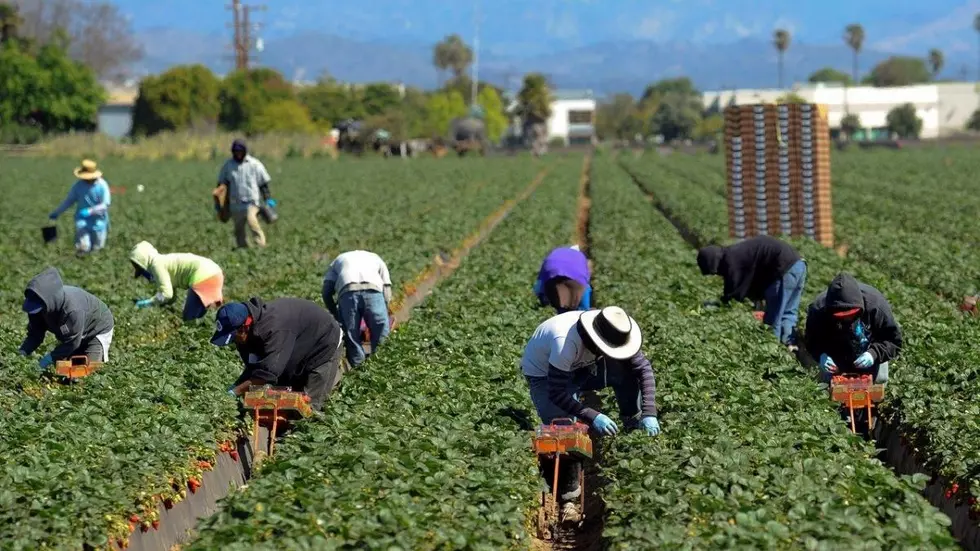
left=521, top=306, right=660, bottom=501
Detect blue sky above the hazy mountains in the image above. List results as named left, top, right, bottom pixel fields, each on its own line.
left=122, top=0, right=980, bottom=55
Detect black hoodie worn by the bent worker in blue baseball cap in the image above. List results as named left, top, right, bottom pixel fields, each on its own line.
left=236, top=297, right=343, bottom=386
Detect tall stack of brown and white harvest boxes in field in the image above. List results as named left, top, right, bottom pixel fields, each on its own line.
left=725, top=104, right=834, bottom=247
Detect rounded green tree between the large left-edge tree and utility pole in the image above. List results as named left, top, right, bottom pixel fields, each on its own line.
left=132, top=65, right=221, bottom=136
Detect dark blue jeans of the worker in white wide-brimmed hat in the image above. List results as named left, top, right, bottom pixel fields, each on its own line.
left=524, top=360, right=642, bottom=424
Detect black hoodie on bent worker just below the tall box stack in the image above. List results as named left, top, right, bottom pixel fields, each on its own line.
left=698, top=235, right=800, bottom=302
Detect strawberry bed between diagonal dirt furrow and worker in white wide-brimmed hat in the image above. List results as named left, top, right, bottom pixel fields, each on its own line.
left=190, top=157, right=580, bottom=549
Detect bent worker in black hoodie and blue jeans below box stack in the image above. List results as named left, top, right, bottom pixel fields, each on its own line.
left=698, top=235, right=806, bottom=346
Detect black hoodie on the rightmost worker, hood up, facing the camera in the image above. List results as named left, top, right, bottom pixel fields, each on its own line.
left=806, top=273, right=902, bottom=369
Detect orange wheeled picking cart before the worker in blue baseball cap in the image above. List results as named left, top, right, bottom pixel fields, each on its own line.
left=242, top=386, right=313, bottom=458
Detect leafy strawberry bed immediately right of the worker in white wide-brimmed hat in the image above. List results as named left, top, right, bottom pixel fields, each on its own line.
left=591, top=157, right=953, bottom=549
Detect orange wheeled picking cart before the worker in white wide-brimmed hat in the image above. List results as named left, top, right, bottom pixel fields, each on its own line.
left=531, top=418, right=592, bottom=537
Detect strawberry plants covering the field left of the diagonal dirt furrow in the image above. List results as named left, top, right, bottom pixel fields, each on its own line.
left=0, top=160, right=541, bottom=549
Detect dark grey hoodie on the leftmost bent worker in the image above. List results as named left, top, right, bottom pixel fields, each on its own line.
left=20, top=268, right=114, bottom=360
